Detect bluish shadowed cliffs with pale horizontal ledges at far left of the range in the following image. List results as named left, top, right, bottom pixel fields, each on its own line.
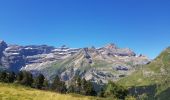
left=0, top=41, right=79, bottom=72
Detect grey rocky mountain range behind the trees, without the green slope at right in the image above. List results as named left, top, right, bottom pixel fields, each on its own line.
left=0, top=40, right=150, bottom=84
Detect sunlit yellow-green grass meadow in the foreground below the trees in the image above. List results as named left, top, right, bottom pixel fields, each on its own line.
left=0, top=83, right=101, bottom=100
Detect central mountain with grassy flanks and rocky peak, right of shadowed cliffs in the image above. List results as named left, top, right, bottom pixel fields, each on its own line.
left=22, top=44, right=148, bottom=84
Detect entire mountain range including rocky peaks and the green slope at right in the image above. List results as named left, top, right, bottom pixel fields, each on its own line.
left=0, top=40, right=170, bottom=100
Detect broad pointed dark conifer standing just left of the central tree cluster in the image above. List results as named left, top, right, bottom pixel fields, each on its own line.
left=51, top=75, right=67, bottom=93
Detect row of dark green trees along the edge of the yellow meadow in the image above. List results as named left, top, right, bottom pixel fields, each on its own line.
left=0, top=71, right=128, bottom=99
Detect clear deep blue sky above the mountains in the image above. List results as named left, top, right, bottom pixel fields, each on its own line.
left=0, top=0, right=170, bottom=58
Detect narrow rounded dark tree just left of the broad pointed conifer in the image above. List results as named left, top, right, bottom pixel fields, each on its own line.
left=34, top=74, right=45, bottom=89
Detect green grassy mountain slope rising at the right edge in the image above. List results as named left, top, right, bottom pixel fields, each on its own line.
left=119, top=48, right=170, bottom=100
